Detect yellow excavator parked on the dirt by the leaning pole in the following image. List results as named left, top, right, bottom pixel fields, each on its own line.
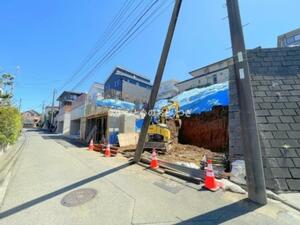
left=144, top=101, right=181, bottom=153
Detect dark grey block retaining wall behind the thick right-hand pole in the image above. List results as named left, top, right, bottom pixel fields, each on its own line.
left=229, top=47, right=300, bottom=192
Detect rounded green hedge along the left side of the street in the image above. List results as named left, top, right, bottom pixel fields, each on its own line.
left=0, top=106, right=22, bottom=146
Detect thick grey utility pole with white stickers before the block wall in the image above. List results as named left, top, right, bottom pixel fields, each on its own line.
left=226, top=0, right=267, bottom=205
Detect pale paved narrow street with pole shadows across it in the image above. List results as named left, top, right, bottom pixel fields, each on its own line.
left=0, top=130, right=300, bottom=225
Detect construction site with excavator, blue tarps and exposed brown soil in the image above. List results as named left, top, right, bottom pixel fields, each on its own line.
left=76, top=82, right=229, bottom=186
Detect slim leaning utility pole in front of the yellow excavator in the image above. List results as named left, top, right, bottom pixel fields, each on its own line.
left=134, top=0, right=182, bottom=162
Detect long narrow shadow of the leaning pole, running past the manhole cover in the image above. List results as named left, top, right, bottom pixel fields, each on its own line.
left=0, top=162, right=133, bottom=219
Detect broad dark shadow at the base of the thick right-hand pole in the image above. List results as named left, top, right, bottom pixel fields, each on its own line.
left=177, top=199, right=261, bottom=225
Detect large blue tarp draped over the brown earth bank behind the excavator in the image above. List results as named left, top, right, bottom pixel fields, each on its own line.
left=154, top=82, right=229, bottom=115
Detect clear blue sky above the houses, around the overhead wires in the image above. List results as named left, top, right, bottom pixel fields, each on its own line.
left=0, top=0, right=300, bottom=111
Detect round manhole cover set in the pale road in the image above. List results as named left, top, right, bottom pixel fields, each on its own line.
left=61, top=188, right=97, bottom=207
